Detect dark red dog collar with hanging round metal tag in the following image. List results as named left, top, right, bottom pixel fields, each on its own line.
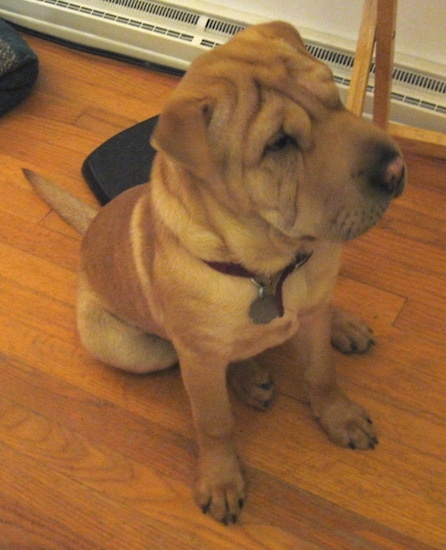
left=205, top=252, right=313, bottom=324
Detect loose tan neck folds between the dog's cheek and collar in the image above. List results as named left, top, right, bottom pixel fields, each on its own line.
left=151, top=155, right=306, bottom=278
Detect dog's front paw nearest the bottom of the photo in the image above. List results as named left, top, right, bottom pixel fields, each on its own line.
left=195, top=457, right=246, bottom=525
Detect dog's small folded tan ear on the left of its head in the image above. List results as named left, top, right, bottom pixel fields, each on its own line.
left=150, top=94, right=215, bottom=179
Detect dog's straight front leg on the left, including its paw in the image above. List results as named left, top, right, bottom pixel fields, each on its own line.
left=179, top=351, right=245, bottom=524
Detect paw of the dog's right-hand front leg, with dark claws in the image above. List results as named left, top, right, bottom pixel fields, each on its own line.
left=317, top=396, right=378, bottom=450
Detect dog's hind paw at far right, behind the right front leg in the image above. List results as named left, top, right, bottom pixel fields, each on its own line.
left=331, top=307, right=375, bottom=353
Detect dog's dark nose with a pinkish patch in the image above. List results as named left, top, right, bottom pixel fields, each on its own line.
left=372, top=149, right=406, bottom=197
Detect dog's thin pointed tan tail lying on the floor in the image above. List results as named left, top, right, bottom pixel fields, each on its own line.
left=23, top=168, right=98, bottom=235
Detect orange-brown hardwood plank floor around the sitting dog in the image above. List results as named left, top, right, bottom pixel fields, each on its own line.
left=0, top=36, right=446, bottom=550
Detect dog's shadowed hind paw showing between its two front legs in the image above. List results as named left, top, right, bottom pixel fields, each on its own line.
left=228, top=359, right=275, bottom=411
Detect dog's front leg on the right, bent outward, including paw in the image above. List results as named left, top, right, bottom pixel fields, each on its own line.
left=295, top=305, right=378, bottom=449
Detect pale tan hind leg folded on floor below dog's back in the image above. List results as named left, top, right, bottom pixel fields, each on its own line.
left=77, top=276, right=178, bottom=374
